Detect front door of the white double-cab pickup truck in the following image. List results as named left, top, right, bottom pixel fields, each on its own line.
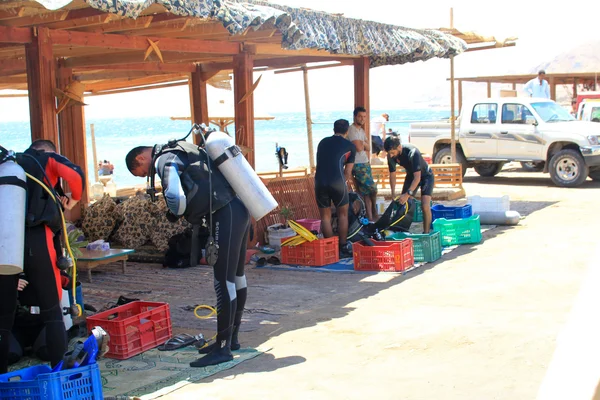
left=498, top=103, right=544, bottom=160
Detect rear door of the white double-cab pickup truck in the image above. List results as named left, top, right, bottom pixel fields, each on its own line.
left=460, top=102, right=498, bottom=159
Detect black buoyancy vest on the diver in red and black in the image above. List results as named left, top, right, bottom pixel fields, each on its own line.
left=17, top=149, right=62, bottom=233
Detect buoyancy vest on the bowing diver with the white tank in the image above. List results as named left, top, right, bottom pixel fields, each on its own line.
left=153, top=141, right=236, bottom=225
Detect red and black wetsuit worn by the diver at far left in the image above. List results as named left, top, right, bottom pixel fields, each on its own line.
left=0, top=149, right=85, bottom=373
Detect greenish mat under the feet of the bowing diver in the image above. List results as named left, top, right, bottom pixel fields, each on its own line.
left=10, top=346, right=264, bottom=400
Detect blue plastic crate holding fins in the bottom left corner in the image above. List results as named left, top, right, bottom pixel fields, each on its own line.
left=0, top=364, right=103, bottom=400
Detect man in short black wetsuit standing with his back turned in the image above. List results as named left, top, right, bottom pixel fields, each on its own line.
left=315, top=119, right=356, bottom=258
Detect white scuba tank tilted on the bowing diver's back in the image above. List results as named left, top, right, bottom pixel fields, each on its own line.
left=206, top=131, right=278, bottom=220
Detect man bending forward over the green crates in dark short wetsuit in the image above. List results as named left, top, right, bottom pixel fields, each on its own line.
left=383, top=136, right=434, bottom=233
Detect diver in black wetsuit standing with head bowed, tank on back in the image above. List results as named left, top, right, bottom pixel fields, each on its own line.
left=126, top=141, right=250, bottom=367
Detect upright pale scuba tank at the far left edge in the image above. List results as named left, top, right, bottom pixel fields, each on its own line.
left=0, top=152, right=27, bottom=275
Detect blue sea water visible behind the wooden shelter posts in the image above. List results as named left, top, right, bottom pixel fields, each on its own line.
left=0, top=108, right=450, bottom=187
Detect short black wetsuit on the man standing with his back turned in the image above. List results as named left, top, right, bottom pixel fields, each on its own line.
left=315, top=135, right=356, bottom=208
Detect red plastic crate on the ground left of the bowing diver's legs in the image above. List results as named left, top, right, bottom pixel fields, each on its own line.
left=87, top=301, right=172, bottom=360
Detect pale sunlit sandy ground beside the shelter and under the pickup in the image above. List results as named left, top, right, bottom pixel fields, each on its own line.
left=145, top=166, right=600, bottom=399
